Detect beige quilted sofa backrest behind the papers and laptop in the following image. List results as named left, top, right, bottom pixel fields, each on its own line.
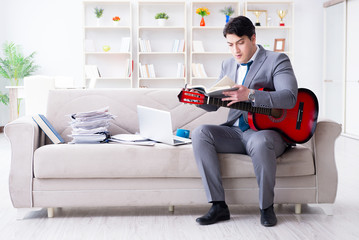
left=46, top=88, right=229, bottom=142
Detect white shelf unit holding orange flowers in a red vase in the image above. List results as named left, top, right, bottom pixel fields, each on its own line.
left=188, top=1, right=241, bottom=87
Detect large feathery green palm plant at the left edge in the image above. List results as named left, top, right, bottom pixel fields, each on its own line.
left=0, top=42, right=39, bottom=119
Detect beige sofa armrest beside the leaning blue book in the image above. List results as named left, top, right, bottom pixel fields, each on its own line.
left=4, top=116, right=45, bottom=208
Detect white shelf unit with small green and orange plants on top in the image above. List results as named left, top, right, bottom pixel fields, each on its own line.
left=83, top=1, right=133, bottom=88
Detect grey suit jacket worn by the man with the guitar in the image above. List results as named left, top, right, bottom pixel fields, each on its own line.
left=202, top=45, right=298, bottom=126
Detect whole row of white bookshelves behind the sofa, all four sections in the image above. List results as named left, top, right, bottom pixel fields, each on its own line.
left=83, top=0, right=294, bottom=88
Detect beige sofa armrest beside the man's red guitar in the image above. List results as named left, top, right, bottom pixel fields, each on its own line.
left=313, top=120, right=342, bottom=203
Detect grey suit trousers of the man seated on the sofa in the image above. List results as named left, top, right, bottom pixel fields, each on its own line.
left=192, top=125, right=287, bottom=209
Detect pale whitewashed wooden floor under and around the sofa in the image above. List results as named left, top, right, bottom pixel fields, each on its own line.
left=0, top=134, right=359, bottom=240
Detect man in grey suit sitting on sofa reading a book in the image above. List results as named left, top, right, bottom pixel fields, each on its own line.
left=192, top=16, right=298, bottom=226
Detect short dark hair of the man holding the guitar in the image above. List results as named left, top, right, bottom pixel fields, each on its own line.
left=223, top=16, right=256, bottom=39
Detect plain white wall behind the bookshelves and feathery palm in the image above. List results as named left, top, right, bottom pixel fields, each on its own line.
left=0, top=0, right=325, bottom=125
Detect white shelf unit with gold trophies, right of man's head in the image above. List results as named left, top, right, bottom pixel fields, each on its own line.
left=244, top=1, right=294, bottom=58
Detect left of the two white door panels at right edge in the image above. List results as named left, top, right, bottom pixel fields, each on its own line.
left=323, top=1, right=346, bottom=124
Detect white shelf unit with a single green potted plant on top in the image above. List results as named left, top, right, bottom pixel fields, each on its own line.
left=137, top=1, right=187, bottom=88
